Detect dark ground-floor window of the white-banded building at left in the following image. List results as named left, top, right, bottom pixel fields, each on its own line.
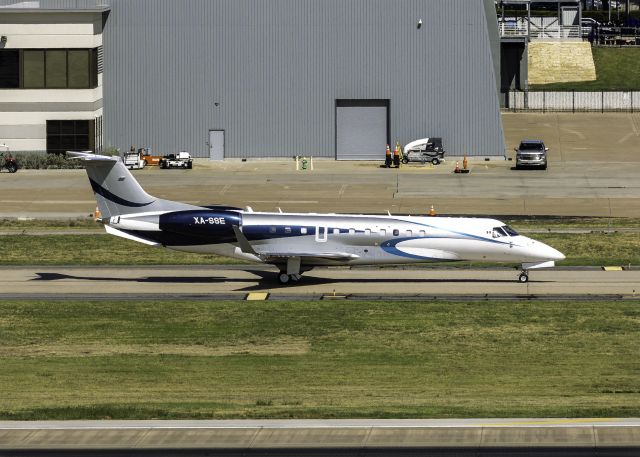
left=47, top=120, right=95, bottom=154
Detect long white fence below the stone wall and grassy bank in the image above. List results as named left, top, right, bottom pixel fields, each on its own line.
left=504, top=90, right=640, bottom=113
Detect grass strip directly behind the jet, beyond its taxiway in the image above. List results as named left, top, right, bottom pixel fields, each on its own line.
left=0, top=232, right=640, bottom=266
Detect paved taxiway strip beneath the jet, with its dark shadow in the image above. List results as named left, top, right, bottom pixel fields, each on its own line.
left=6, top=266, right=640, bottom=299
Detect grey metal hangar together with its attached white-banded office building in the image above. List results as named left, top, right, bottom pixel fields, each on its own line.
left=0, top=0, right=505, bottom=160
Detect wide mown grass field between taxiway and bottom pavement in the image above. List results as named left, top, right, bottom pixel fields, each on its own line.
left=0, top=301, right=640, bottom=420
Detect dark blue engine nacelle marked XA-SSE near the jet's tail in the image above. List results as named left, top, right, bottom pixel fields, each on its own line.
left=160, top=210, right=242, bottom=243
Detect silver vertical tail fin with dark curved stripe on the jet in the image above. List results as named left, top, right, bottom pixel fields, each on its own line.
left=68, top=152, right=194, bottom=218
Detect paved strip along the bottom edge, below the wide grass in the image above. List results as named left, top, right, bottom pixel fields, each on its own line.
left=0, top=419, right=640, bottom=457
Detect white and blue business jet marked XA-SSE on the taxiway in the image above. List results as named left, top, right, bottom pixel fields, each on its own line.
left=69, top=152, right=565, bottom=284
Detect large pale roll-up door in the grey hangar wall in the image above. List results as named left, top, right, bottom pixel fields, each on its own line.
left=336, top=100, right=389, bottom=160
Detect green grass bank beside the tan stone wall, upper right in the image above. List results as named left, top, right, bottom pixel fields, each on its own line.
left=531, top=47, right=640, bottom=91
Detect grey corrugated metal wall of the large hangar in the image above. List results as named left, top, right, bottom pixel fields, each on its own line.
left=2, top=0, right=505, bottom=157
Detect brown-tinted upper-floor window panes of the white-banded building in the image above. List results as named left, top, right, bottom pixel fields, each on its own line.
left=20, top=49, right=98, bottom=89
